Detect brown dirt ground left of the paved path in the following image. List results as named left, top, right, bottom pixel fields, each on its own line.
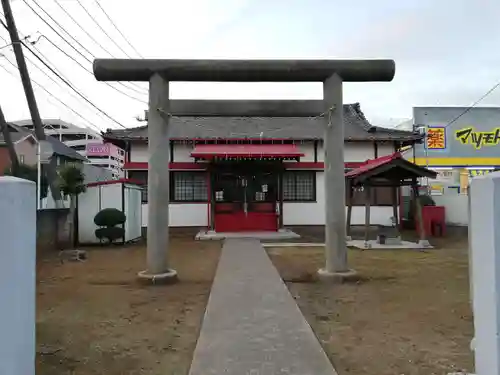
left=36, top=237, right=221, bottom=375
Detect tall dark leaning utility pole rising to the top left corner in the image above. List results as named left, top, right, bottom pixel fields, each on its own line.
left=1, top=0, right=62, bottom=207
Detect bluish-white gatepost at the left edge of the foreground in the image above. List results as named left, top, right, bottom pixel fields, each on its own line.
left=0, top=177, right=36, bottom=375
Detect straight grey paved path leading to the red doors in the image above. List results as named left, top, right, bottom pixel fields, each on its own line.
left=189, top=239, right=336, bottom=375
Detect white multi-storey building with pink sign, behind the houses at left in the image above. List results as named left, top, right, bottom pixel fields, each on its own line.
left=13, top=119, right=125, bottom=178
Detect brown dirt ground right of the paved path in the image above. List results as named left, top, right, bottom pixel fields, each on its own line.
left=269, top=241, right=473, bottom=375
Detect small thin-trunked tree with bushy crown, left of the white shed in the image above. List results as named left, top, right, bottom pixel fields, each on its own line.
left=59, top=163, right=87, bottom=250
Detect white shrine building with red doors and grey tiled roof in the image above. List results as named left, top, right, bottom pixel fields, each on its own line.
left=103, top=100, right=421, bottom=231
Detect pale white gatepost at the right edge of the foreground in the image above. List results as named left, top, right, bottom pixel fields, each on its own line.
left=470, top=173, right=500, bottom=375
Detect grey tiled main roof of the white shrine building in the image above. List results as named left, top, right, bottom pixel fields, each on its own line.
left=103, top=101, right=422, bottom=141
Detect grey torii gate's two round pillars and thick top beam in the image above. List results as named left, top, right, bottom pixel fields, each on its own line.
left=94, top=59, right=395, bottom=283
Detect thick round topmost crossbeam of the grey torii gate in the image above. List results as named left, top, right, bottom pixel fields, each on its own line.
left=93, top=59, right=396, bottom=82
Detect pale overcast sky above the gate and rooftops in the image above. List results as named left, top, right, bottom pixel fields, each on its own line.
left=0, top=0, right=500, bottom=133
